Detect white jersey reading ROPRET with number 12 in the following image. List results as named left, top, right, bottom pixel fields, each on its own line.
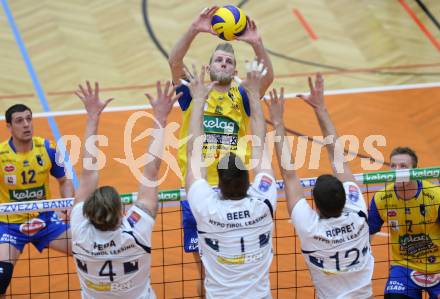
left=292, top=182, right=374, bottom=299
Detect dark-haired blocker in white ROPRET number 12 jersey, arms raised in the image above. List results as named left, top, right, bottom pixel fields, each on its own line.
left=269, top=73, right=374, bottom=299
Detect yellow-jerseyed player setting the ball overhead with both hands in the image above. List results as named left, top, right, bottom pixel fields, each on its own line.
left=169, top=6, right=273, bottom=252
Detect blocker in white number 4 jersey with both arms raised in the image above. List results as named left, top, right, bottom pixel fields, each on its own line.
left=71, top=81, right=179, bottom=299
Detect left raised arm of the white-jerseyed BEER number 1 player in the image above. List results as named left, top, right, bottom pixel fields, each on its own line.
left=185, top=65, right=217, bottom=192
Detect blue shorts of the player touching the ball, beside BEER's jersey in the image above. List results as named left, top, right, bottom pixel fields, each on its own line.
left=180, top=200, right=199, bottom=252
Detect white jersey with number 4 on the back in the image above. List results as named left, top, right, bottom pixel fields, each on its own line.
left=70, top=203, right=156, bottom=299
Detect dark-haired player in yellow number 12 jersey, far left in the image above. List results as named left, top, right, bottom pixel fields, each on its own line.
left=0, top=104, right=74, bottom=298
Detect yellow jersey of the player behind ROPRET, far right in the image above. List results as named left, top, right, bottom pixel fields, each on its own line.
left=368, top=181, right=440, bottom=274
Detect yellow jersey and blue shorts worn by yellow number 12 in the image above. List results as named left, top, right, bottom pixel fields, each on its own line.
left=0, top=137, right=69, bottom=251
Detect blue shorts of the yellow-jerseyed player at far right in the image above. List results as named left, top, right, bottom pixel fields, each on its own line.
left=385, top=266, right=440, bottom=299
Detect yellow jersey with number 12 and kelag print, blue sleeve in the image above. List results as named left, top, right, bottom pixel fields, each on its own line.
left=0, top=137, right=65, bottom=223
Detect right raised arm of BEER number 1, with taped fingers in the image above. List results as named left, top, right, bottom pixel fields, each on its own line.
left=241, top=60, right=273, bottom=176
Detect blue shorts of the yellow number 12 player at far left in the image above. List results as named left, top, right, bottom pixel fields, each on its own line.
left=0, top=211, right=70, bottom=252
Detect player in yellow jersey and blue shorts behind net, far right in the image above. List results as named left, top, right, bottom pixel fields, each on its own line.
left=368, top=147, right=440, bottom=299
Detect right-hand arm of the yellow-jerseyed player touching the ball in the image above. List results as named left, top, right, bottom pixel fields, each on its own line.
left=237, top=17, right=273, bottom=97
